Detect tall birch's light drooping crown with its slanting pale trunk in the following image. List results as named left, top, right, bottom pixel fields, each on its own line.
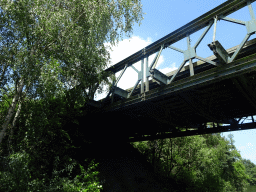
left=0, top=0, right=142, bottom=143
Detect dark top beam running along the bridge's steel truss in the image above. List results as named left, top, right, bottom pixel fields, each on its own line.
left=105, top=0, right=256, bottom=73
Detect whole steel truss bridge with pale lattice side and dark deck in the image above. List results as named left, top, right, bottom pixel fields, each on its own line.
left=82, top=0, right=256, bottom=142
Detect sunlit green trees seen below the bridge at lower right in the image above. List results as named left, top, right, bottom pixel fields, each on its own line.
left=133, top=134, right=248, bottom=192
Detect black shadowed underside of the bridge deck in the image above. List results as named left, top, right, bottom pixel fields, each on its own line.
left=90, top=71, right=256, bottom=140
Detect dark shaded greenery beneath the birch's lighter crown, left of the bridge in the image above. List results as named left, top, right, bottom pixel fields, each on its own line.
left=0, top=89, right=103, bottom=191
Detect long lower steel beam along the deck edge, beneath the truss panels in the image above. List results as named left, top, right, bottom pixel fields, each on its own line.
left=106, top=53, right=256, bottom=110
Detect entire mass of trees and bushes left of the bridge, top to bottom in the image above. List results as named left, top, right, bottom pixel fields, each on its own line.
left=0, top=0, right=143, bottom=191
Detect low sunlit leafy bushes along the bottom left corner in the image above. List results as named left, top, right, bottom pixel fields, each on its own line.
left=0, top=152, right=102, bottom=192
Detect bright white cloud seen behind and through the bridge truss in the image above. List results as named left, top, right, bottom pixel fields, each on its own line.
left=95, top=36, right=177, bottom=100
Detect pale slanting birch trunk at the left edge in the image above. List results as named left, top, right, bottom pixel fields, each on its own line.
left=0, top=78, right=24, bottom=144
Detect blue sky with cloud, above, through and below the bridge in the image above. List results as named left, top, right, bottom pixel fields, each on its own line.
left=100, top=0, right=256, bottom=164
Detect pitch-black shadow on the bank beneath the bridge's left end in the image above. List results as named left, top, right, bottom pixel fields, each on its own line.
left=61, top=109, right=179, bottom=192
